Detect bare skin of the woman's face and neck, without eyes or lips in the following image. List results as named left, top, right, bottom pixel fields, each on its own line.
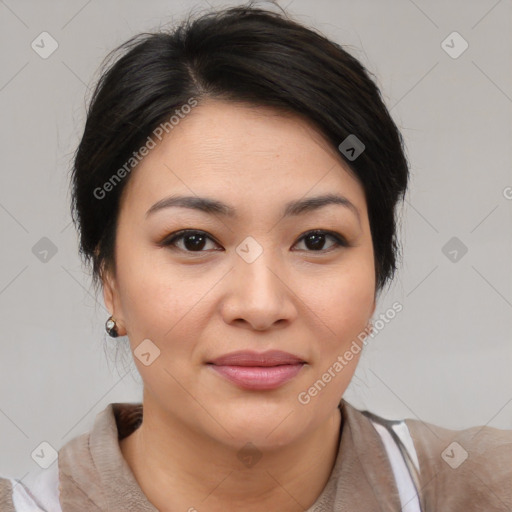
left=103, top=100, right=375, bottom=512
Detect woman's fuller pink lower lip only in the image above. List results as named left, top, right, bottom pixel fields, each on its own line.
left=210, top=363, right=304, bottom=389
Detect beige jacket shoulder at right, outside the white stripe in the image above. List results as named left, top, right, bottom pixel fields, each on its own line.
left=405, top=419, right=512, bottom=510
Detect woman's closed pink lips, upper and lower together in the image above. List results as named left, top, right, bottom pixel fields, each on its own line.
left=208, top=350, right=306, bottom=390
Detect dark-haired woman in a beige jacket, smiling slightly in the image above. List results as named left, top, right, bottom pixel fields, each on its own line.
left=0, top=6, right=512, bottom=512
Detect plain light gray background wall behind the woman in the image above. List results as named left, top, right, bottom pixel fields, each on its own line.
left=0, top=0, right=512, bottom=481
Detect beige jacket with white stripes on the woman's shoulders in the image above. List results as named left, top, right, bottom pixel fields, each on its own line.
left=0, top=400, right=512, bottom=512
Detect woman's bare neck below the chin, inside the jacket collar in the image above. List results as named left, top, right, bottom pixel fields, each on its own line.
left=119, top=408, right=342, bottom=512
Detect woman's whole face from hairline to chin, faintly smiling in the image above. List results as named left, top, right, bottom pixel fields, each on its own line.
left=104, top=100, right=375, bottom=448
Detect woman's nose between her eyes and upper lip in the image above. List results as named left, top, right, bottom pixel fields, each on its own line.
left=222, top=251, right=298, bottom=331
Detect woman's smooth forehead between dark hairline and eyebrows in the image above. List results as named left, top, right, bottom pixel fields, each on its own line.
left=121, top=100, right=366, bottom=218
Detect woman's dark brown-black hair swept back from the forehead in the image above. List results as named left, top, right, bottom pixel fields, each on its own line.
left=71, top=2, right=409, bottom=293
